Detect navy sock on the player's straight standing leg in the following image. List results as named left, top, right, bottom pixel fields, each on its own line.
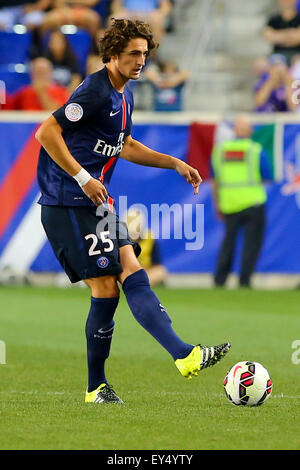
left=85, top=297, right=119, bottom=392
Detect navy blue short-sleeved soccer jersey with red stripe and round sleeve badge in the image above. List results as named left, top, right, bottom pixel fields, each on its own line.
left=37, top=67, right=133, bottom=206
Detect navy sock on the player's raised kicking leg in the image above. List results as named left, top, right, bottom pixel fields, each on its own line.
left=123, top=269, right=194, bottom=360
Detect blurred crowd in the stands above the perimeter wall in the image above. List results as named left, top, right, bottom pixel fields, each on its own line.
left=0, top=0, right=300, bottom=113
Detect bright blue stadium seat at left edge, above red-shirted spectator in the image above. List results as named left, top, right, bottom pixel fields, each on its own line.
left=0, top=30, right=31, bottom=64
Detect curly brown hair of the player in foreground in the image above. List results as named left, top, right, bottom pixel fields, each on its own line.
left=99, top=19, right=158, bottom=64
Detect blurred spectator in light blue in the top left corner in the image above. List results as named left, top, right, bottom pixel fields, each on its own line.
left=0, top=0, right=51, bottom=31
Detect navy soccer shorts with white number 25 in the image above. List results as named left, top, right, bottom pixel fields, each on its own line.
left=42, top=206, right=141, bottom=283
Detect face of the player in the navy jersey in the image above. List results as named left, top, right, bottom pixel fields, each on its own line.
left=117, top=38, right=148, bottom=80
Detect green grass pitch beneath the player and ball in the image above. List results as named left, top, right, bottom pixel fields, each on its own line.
left=0, top=287, right=300, bottom=450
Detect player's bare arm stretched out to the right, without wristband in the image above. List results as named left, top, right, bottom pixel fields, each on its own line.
left=120, top=135, right=202, bottom=194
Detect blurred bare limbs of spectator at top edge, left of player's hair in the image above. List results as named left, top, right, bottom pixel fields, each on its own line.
left=43, top=0, right=101, bottom=37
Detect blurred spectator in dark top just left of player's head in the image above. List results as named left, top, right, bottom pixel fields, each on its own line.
left=44, top=30, right=82, bottom=95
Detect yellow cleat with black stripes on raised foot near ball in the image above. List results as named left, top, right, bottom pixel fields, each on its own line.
left=175, top=343, right=231, bottom=379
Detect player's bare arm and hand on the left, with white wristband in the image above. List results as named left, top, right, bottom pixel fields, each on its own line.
left=35, top=116, right=107, bottom=206
